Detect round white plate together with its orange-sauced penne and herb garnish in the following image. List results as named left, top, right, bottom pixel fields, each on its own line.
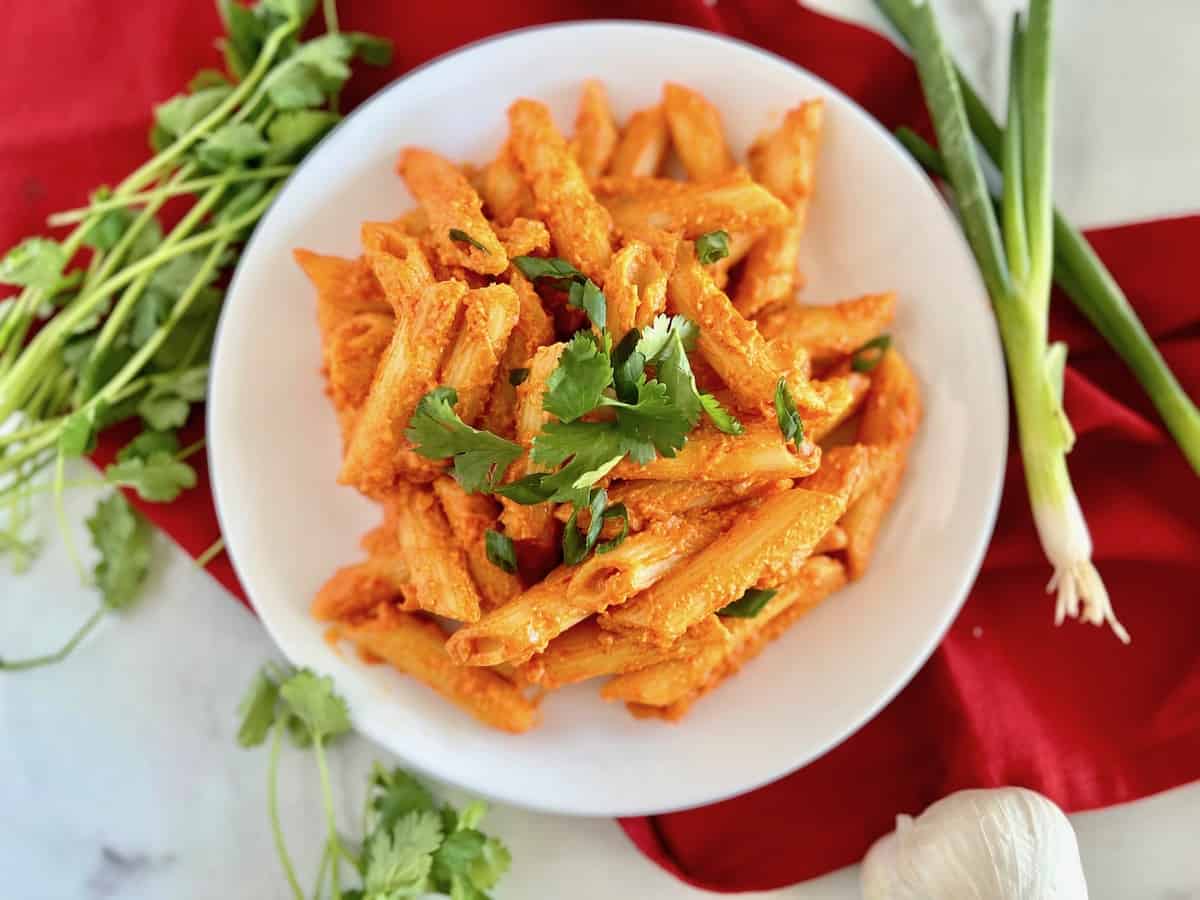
left=209, top=23, right=1007, bottom=815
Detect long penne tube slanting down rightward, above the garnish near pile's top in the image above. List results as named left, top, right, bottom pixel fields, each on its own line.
left=509, top=100, right=612, bottom=282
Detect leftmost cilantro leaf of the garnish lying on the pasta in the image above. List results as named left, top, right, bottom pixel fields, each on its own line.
left=404, top=388, right=524, bottom=493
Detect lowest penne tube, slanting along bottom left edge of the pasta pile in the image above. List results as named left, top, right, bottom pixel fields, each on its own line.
left=337, top=612, right=538, bottom=733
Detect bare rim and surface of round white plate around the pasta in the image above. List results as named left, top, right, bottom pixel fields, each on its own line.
left=208, top=23, right=1008, bottom=815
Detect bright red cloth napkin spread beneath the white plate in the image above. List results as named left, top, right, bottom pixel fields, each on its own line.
left=0, top=0, right=1200, bottom=890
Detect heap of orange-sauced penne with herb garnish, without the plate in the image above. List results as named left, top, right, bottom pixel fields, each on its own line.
left=296, top=80, right=920, bottom=732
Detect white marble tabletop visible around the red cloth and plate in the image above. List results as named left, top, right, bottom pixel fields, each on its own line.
left=0, top=0, right=1200, bottom=900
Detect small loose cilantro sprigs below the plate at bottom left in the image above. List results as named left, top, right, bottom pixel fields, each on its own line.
left=238, top=665, right=511, bottom=900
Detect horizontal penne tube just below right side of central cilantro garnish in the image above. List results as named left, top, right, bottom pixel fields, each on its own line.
left=611, top=422, right=821, bottom=481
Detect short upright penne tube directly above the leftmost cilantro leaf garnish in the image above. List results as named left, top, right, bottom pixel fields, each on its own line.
left=439, top=284, right=521, bottom=425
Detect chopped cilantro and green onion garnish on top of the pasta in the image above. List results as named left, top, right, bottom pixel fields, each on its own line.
left=406, top=247, right=744, bottom=568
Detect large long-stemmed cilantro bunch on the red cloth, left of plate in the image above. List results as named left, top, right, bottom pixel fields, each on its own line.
left=0, top=0, right=390, bottom=662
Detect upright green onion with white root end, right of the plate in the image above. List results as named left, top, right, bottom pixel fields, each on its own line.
left=902, top=0, right=1129, bottom=642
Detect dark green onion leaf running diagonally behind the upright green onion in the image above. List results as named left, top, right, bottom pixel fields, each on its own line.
left=875, top=0, right=1200, bottom=474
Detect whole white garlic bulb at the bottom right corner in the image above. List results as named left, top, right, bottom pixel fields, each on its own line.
left=862, top=787, right=1087, bottom=900
